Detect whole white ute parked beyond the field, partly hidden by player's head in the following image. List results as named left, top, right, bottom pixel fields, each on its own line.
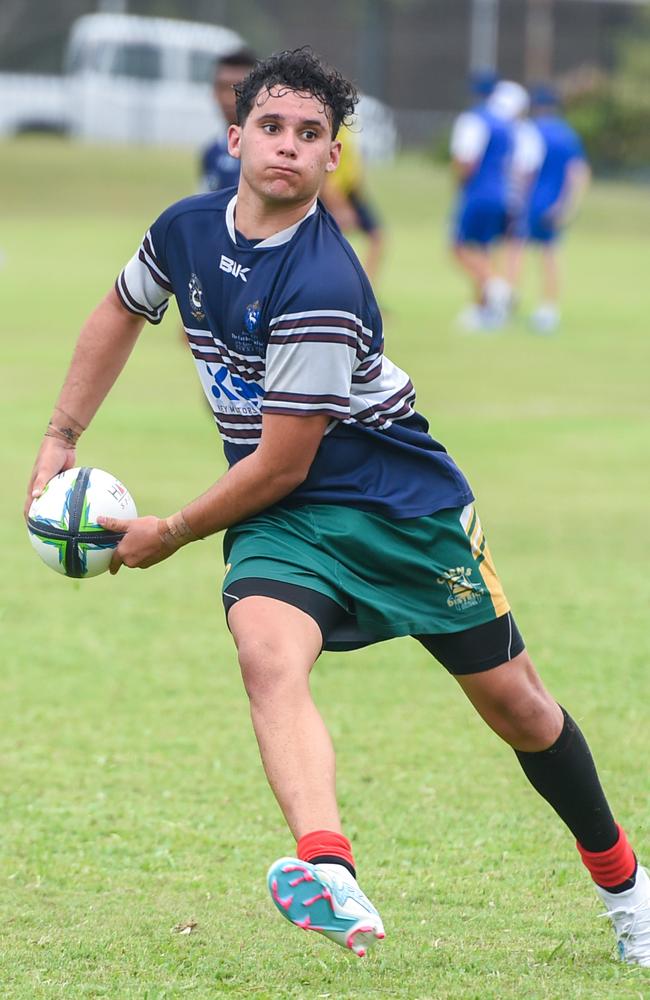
left=0, top=14, right=398, bottom=160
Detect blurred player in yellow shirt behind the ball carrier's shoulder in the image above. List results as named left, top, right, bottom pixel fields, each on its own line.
left=320, top=127, right=385, bottom=284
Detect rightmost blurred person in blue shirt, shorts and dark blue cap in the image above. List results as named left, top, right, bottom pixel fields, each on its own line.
left=510, top=86, right=591, bottom=333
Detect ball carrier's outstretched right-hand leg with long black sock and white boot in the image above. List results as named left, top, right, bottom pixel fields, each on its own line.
left=456, top=650, right=650, bottom=967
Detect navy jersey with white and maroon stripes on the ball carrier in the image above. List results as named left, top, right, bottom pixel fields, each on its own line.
left=116, top=191, right=473, bottom=518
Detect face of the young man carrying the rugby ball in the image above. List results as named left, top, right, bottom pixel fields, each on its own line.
left=228, top=87, right=341, bottom=205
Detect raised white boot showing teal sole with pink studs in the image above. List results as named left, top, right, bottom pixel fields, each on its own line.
left=267, top=858, right=385, bottom=958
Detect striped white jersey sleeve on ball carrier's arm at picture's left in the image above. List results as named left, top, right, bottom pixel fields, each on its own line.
left=115, top=215, right=174, bottom=324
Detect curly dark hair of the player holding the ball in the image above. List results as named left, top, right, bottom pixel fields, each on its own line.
left=233, top=45, right=359, bottom=139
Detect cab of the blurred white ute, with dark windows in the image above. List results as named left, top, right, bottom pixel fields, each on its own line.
left=65, top=14, right=244, bottom=146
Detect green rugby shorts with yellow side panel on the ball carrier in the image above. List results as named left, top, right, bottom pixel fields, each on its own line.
left=223, top=504, right=510, bottom=649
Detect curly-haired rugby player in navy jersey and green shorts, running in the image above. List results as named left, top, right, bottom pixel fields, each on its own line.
left=28, top=49, right=650, bottom=965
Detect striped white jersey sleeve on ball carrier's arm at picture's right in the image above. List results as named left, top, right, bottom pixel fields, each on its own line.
left=262, top=273, right=370, bottom=420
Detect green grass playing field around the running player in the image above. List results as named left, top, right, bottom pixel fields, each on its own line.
left=0, top=140, right=650, bottom=1000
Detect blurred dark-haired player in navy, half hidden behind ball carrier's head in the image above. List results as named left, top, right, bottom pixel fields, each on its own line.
left=201, top=49, right=256, bottom=191
